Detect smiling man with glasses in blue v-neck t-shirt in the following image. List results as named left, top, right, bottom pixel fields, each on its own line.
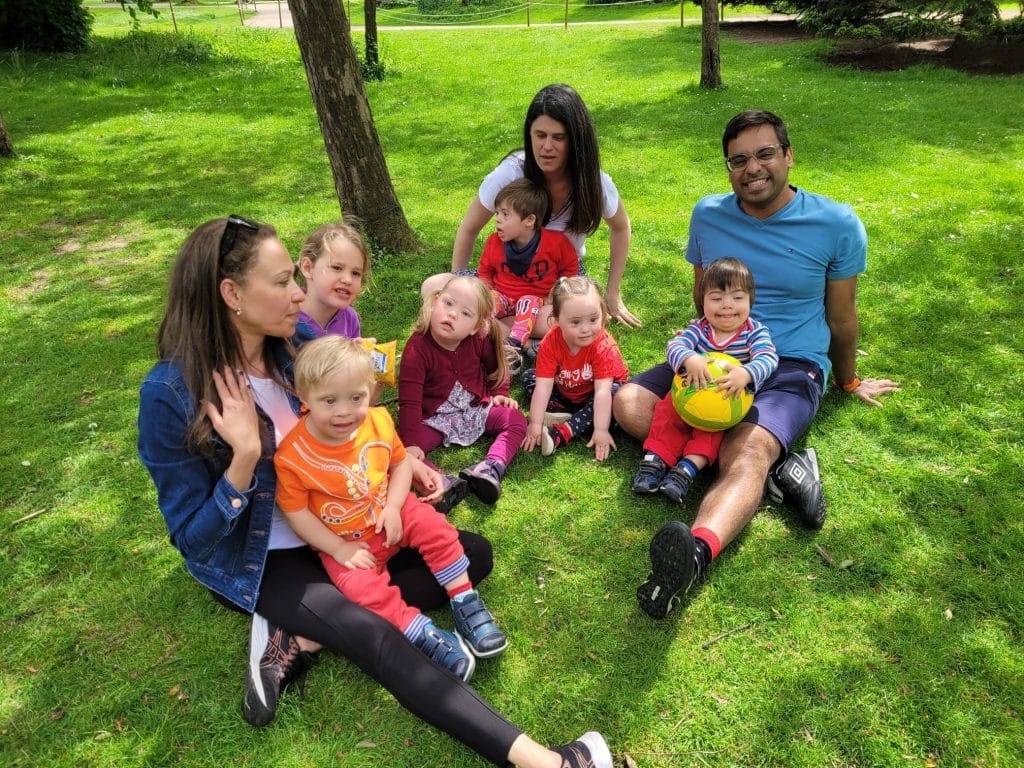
left=613, top=111, right=899, bottom=618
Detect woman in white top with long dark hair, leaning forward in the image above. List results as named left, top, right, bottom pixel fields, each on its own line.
left=422, top=85, right=640, bottom=331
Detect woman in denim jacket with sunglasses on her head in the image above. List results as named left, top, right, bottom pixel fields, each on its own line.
left=138, top=216, right=611, bottom=768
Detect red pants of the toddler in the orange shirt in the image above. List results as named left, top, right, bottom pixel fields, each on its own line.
left=321, top=494, right=468, bottom=631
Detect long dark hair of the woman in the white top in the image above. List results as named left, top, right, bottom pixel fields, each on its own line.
left=522, top=83, right=604, bottom=234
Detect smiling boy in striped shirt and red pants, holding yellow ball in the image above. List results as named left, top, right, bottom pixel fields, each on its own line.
left=633, top=258, right=778, bottom=502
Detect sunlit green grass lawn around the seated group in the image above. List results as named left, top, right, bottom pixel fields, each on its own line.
left=0, top=16, right=1024, bottom=768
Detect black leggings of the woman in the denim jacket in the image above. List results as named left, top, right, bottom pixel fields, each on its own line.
left=214, top=531, right=522, bottom=766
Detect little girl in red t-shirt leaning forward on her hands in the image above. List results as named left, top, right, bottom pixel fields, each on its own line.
left=522, top=276, right=630, bottom=461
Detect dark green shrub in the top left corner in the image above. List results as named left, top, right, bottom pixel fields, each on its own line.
left=0, top=0, right=92, bottom=53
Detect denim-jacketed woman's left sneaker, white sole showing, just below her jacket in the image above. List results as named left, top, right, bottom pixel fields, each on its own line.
left=242, top=613, right=313, bottom=728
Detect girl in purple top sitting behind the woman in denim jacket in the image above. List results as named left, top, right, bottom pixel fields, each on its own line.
left=297, top=223, right=370, bottom=339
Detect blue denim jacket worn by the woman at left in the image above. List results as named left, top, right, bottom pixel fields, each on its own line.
left=138, top=339, right=299, bottom=612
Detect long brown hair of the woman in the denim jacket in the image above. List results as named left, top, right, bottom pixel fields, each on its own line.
left=157, top=218, right=285, bottom=455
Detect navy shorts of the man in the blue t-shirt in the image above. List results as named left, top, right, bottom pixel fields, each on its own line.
left=629, top=357, right=824, bottom=455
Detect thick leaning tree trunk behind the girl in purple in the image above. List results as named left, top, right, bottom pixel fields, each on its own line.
left=288, top=0, right=419, bottom=252
